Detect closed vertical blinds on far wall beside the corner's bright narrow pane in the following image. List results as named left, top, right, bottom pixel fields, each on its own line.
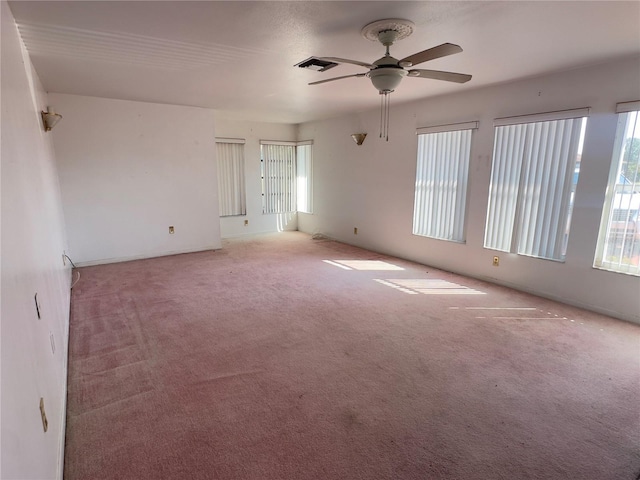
left=260, top=142, right=296, bottom=213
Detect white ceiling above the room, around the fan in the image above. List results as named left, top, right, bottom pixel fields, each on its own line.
left=10, top=1, right=640, bottom=123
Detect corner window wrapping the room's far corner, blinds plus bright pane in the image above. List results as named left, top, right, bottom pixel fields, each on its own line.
left=260, top=141, right=312, bottom=213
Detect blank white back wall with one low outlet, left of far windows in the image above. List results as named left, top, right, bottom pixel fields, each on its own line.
left=49, top=94, right=221, bottom=264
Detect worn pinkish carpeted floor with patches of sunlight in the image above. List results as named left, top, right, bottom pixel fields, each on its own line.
left=65, top=232, right=640, bottom=480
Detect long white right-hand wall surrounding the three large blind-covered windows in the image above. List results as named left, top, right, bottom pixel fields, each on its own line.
left=298, top=58, right=640, bottom=322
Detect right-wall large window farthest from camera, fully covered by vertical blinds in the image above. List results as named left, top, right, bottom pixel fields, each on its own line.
left=413, top=122, right=478, bottom=242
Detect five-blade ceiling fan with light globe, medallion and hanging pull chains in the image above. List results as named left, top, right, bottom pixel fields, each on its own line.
left=296, top=18, right=471, bottom=140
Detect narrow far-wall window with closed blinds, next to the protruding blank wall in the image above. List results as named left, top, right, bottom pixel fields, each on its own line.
left=216, top=139, right=247, bottom=217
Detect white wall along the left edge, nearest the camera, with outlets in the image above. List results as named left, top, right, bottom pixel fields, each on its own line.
left=0, top=1, right=71, bottom=480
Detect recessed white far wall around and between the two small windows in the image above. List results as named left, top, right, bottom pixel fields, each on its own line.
left=216, top=116, right=298, bottom=238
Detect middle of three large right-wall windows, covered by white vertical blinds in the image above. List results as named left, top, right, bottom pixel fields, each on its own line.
left=484, top=109, right=589, bottom=261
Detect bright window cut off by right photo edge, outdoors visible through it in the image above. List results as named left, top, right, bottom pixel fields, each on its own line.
left=594, top=102, right=640, bottom=275
